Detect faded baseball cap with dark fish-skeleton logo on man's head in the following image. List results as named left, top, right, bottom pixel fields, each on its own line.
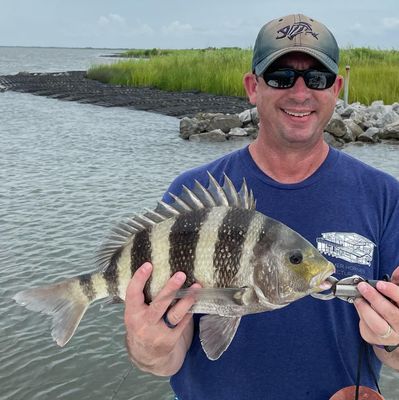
left=252, top=14, right=339, bottom=75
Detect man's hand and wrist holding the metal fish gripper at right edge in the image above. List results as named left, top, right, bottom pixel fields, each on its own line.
left=355, top=267, right=399, bottom=370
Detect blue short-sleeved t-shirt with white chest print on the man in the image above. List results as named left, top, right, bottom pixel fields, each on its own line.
left=166, top=148, right=399, bottom=400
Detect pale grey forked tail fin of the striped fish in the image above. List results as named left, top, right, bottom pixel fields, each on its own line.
left=13, top=278, right=95, bottom=347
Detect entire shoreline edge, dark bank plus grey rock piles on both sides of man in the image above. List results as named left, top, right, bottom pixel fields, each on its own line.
left=0, top=71, right=399, bottom=147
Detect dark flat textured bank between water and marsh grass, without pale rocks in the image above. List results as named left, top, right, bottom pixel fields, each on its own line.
left=0, top=71, right=251, bottom=118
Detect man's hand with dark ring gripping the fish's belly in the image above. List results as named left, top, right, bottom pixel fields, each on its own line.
left=125, top=263, right=200, bottom=376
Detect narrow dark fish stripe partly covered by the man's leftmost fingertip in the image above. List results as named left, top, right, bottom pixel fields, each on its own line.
left=130, top=228, right=152, bottom=303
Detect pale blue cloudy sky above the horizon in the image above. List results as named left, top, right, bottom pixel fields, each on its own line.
left=0, top=0, right=399, bottom=49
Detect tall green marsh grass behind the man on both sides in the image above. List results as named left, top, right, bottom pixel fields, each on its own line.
left=88, top=48, right=399, bottom=105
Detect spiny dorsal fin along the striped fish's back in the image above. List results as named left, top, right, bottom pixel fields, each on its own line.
left=96, top=171, right=255, bottom=269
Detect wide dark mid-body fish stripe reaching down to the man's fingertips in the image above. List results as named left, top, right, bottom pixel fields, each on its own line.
left=169, top=208, right=209, bottom=287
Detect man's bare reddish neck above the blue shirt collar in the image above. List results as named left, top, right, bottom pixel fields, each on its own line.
left=249, top=137, right=329, bottom=184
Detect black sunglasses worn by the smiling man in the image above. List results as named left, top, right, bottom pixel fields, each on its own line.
left=262, top=68, right=337, bottom=90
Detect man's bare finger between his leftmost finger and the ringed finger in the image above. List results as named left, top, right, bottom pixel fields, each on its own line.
left=148, top=271, right=186, bottom=324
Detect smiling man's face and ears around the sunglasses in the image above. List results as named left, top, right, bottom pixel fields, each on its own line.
left=245, top=52, right=343, bottom=147
